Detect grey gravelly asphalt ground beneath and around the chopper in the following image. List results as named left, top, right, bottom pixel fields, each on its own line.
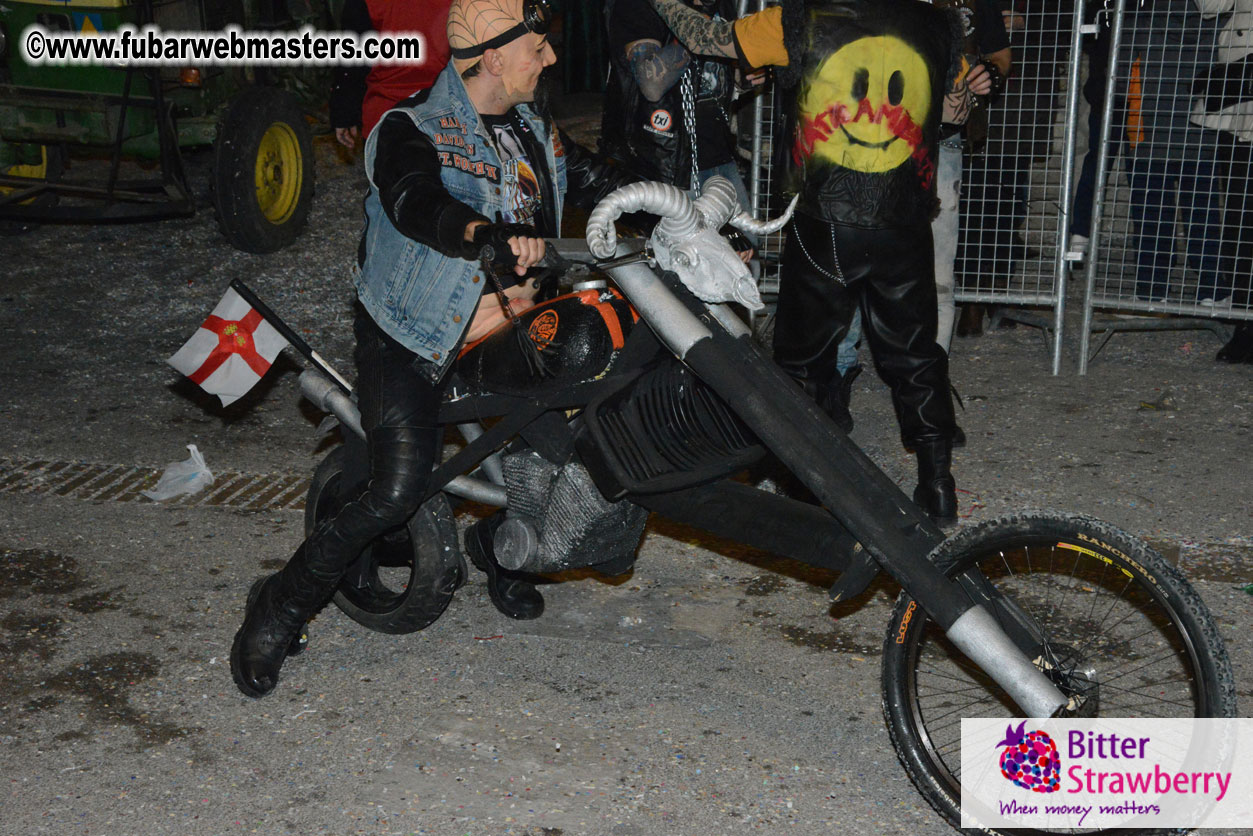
left=0, top=104, right=1253, bottom=836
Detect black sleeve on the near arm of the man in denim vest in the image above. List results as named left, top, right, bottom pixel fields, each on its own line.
left=372, top=113, right=489, bottom=256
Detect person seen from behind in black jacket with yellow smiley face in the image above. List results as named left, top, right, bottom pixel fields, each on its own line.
left=650, top=0, right=992, bottom=525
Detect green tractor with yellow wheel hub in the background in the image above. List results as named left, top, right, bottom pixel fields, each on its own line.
left=0, top=0, right=335, bottom=253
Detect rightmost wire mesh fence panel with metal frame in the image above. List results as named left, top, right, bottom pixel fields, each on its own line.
left=1075, top=0, right=1253, bottom=372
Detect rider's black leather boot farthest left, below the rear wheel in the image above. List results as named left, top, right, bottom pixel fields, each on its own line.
left=231, top=544, right=338, bottom=697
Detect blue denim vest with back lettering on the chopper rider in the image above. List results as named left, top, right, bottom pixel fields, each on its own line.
left=356, top=64, right=565, bottom=376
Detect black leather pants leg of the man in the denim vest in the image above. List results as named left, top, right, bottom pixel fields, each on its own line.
left=304, top=307, right=442, bottom=582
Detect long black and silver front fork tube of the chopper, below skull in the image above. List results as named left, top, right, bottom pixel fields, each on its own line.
left=611, top=264, right=1066, bottom=717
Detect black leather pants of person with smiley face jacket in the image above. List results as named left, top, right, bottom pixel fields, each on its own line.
left=774, top=213, right=956, bottom=446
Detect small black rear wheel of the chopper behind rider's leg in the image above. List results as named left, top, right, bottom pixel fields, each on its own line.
left=304, top=447, right=466, bottom=633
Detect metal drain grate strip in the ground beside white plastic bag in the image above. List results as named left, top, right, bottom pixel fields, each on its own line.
left=0, top=456, right=309, bottom=511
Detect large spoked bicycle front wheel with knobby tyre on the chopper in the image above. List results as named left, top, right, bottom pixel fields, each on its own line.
left=883, top=513, right=1235, bottom=835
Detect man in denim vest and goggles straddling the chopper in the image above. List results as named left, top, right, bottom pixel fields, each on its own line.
left=231, top=0, right=633, bottom=697
